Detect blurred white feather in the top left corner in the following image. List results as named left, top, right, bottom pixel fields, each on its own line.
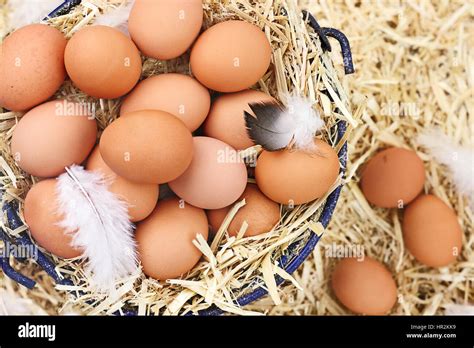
left=7, top=0, right=64, bottom=30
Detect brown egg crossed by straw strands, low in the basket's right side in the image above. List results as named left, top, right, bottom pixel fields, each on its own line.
left=206, top=184, right=280, bottom=236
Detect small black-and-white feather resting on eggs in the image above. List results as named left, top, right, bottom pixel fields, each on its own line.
left=244, top=96, right=324, bottom=151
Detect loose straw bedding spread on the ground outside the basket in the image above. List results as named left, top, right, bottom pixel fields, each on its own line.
left=0, top=0, right=474, bottom=315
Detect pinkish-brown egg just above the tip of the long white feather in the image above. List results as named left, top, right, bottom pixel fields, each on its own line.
left=11, top=100, right=97, bottom=177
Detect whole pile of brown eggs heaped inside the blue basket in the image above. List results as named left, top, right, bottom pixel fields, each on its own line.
left=0, top=0, right=339, bottom=279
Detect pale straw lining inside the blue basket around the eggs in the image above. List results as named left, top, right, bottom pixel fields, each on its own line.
left=0, top=0, right=356, bottom=315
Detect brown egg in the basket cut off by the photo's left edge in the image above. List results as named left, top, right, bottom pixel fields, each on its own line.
left=0, top=24, right=66, bottom=111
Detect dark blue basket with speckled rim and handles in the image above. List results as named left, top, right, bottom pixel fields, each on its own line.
left=0, top=0, right=353, bottom=315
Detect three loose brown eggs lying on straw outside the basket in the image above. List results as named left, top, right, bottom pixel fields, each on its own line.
left=332, top=147, right=462, bottom=315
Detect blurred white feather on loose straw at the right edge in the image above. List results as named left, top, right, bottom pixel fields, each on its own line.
left=418, top=129, right=474, bottom=208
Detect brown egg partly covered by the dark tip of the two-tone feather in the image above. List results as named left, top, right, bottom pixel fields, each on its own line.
left=204, top=89, right=276, bottom=150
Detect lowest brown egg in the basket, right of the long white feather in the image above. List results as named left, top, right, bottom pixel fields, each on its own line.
left=135, top=198, right=208, bottom=280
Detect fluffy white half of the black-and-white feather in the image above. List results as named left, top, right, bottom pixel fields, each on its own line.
left=286, top=95, right=324, bottom=150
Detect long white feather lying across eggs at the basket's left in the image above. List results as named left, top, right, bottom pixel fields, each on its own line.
left=57, top=165, right=138, bottom=291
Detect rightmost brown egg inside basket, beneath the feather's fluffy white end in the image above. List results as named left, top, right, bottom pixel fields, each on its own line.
left=255, top=139, right=339, bottom=205
